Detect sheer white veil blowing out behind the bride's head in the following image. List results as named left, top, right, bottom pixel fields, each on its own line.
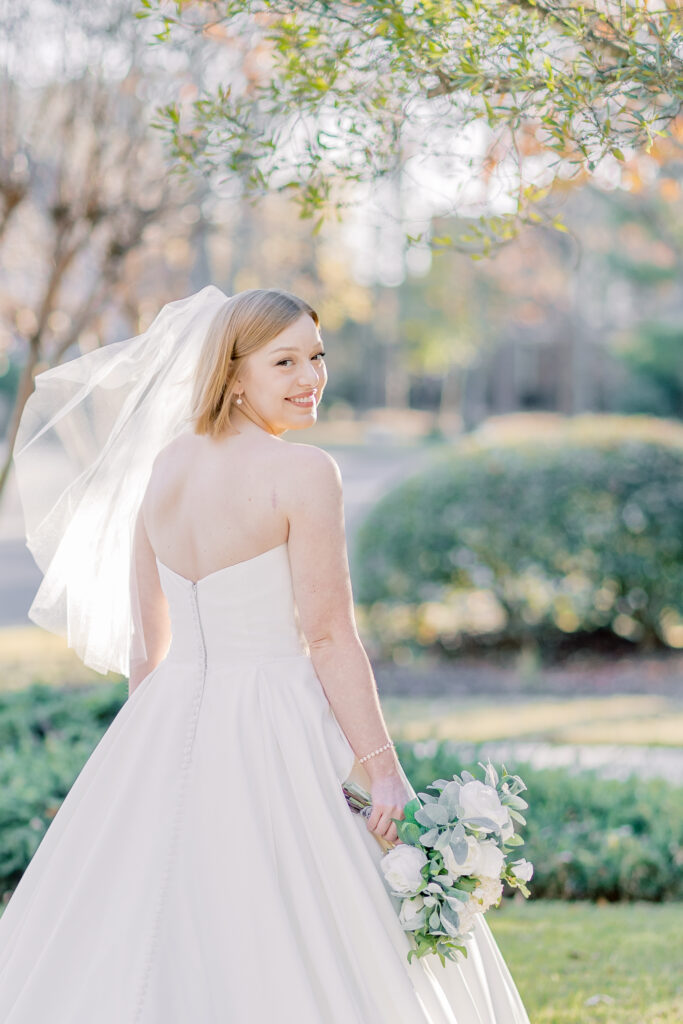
left=13, top=285, right=229, bottom=676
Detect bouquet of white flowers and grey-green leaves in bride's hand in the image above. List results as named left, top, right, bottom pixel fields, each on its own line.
left=343, top=762, right=533, bottom=966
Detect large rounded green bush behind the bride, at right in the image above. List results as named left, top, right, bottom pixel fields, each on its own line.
left=354, top=416, right=683, bottom=652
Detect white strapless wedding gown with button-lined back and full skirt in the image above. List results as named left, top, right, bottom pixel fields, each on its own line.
left=0, top=544, right=528, bottom=1024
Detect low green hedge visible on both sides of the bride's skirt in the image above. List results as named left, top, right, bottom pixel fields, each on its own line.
left=0, top=683, right=683, bottom=900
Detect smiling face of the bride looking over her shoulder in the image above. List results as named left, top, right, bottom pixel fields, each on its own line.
left=235, top=313, right=328, bottom=434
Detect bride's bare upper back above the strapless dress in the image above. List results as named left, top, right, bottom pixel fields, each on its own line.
left=142, top=430, right=298, bottom=580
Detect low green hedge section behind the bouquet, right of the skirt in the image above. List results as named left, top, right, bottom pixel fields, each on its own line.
left=397, top=740, right=683, bottom=902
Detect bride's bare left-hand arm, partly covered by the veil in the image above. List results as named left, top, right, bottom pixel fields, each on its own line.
left=128, top=508, right=171, bottom=696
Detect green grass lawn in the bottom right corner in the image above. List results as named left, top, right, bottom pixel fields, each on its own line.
left=488, top=900, right=683, bottom=1024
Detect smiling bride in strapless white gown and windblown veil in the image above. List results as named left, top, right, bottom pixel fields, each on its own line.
left=0, top=286, right=528, bottom=1024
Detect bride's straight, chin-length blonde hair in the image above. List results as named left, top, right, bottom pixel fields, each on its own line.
left=190, top=288, right=319, bottom=437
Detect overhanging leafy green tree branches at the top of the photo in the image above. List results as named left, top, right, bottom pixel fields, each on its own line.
left=136, top=0, right=683, bottom=251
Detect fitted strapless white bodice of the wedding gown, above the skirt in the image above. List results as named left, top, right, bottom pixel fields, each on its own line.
left=157, top=543, right=309, bottom=670
